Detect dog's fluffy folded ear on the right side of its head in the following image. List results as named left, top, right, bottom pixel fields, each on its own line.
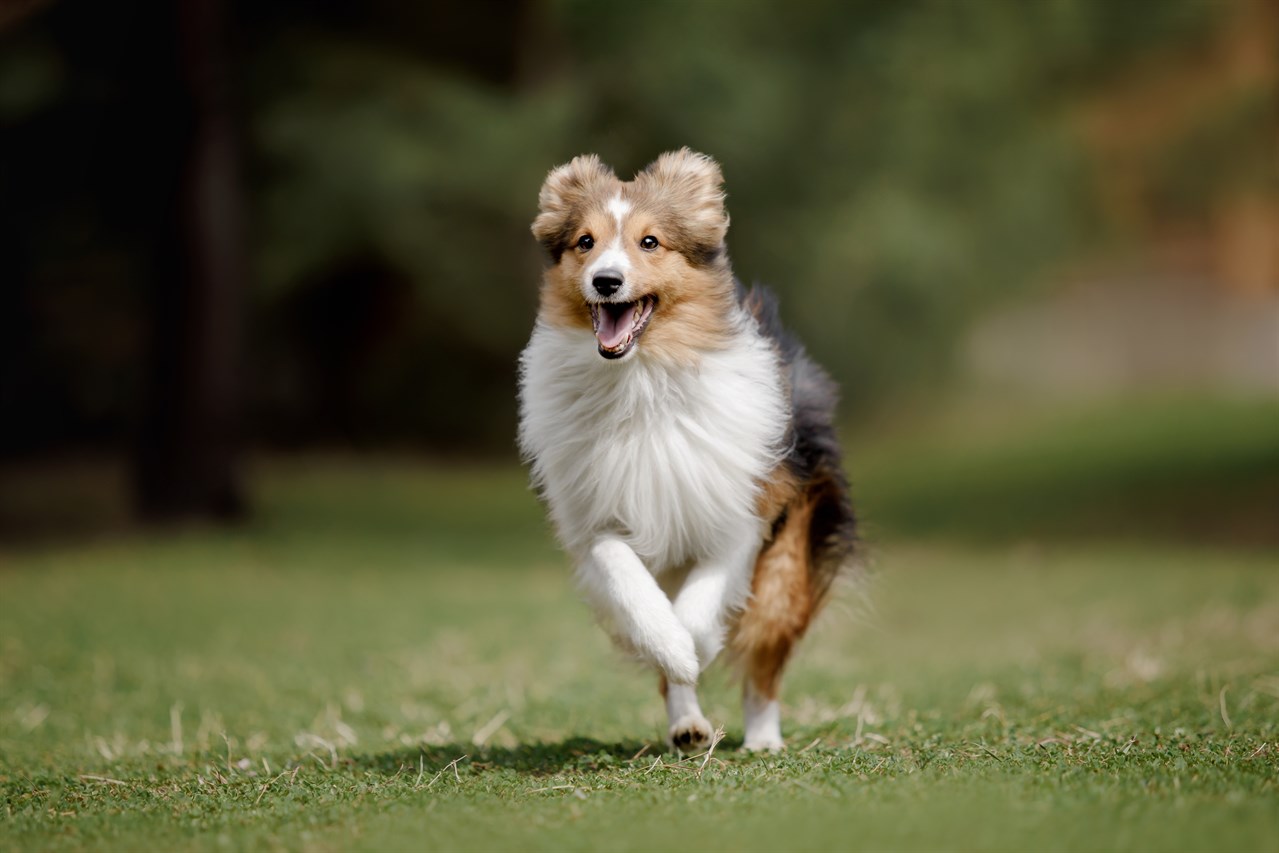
left=640, top=148, right=728, bottom=253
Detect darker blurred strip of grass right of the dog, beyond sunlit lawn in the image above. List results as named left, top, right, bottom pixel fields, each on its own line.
left=853, top=398, right=1279, bottom=545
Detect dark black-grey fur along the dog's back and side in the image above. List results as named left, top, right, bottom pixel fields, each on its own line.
left=737, top=281, right=857, bottom=599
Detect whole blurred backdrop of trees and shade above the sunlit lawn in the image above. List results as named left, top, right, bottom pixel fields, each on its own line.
left=0, top=0, right=1279, bottom=542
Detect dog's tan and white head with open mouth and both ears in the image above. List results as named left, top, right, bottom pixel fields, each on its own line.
left=532, top=148, right=733, bottom=359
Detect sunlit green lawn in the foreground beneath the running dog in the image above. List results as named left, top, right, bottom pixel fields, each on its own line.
left=0, top=529, right=1279, bottom=849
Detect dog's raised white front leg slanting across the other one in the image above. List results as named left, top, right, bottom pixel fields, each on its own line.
left=578, top=537, right=698, bottom=685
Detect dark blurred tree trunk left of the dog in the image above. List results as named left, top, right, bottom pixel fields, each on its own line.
left=127, top=0, right=247, bottom=519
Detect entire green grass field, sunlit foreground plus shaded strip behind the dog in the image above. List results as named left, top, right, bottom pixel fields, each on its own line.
left=0, top=404, right=1279, bottom=850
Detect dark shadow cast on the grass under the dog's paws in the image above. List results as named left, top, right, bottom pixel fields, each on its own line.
left=349, top=738, right=742, bottom=776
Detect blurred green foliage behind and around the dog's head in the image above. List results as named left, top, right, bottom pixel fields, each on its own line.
left=246, top=0, right=1220, bottom=419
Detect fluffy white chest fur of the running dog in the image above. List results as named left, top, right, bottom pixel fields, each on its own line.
left=519, top=322, right=789, bottom=574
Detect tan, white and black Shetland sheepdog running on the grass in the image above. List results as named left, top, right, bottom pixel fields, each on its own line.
left=519, top=148, right=854, bottom=752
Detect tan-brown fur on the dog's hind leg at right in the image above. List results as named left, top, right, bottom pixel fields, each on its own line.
left=730, top=494, right=820, bottom=698
